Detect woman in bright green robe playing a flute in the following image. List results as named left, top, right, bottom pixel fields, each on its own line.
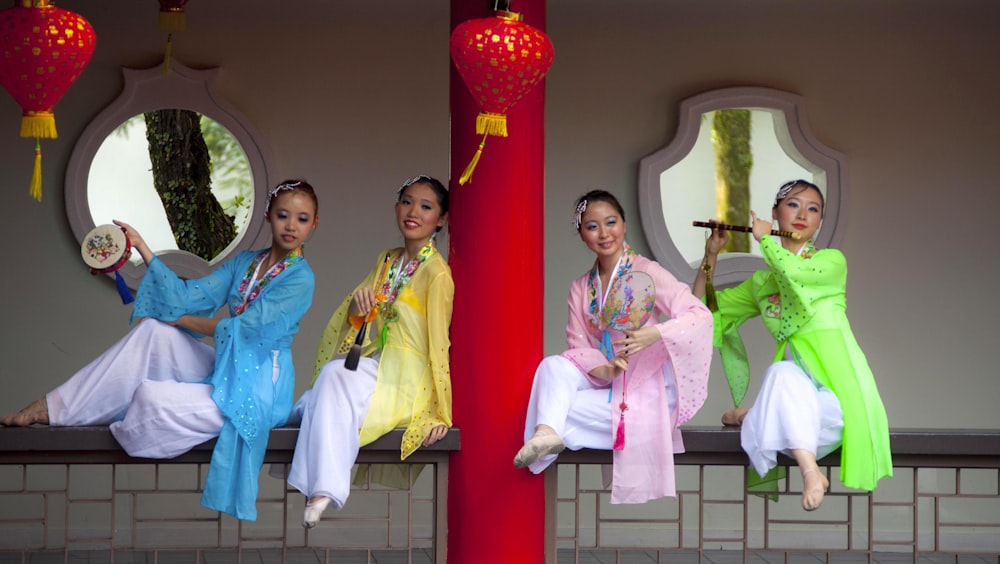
left=694, top=180, right=892, bottom=511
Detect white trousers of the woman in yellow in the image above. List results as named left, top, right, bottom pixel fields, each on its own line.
left=288, top=357, right=378, bottom=509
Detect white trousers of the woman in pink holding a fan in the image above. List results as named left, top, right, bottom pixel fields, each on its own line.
left=524, top=355, right=677, bottom=474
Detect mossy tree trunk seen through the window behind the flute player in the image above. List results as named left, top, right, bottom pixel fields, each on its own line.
left=712, top=110, right=753, bottom=253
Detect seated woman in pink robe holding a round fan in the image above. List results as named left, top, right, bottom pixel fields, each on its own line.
left=514, top=190, right=712, bottom=503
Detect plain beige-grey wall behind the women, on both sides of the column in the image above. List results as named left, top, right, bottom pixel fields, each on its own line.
left=0, top=0, right=1000, bottom=434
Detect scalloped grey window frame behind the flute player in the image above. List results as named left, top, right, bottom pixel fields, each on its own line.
left=638, top=87, right=847, bottom=287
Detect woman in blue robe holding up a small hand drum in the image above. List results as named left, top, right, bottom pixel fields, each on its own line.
left=0, top=180, right=319, bottom=521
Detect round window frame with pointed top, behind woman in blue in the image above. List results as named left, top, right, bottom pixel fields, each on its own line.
left=66, top=60, right=271, bottom=289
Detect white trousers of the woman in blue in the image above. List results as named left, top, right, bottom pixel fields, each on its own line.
left=46, top=319, right=224, bottom=458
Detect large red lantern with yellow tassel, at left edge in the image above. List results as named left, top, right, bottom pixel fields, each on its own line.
left=0, top=0, right=97, bottom=201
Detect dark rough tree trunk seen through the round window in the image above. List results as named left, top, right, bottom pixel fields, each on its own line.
left=144, top=109, right=236, bottom=260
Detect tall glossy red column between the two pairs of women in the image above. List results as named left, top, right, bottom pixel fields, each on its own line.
left=448, top=0, right=545, bottom=564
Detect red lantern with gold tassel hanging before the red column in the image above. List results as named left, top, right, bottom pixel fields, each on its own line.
left=451, top=10, right=555, bottom=184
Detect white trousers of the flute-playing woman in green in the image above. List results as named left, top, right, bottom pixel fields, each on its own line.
left=740, top=360, right=844, bottom=476
